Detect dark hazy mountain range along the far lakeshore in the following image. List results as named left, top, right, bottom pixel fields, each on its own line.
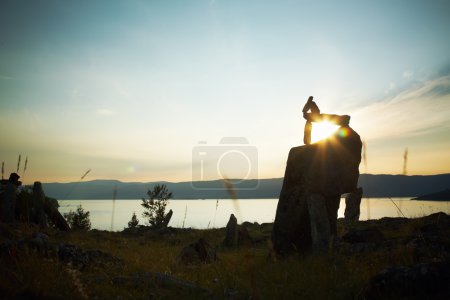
left=39, top=174, right=450, bottom=200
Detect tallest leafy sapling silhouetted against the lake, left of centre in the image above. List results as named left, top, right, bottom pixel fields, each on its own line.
left=141, top=184, right=172, bottom=227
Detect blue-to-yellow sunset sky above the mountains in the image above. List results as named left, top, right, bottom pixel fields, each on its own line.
left=0, top=0, right=450, bottom=183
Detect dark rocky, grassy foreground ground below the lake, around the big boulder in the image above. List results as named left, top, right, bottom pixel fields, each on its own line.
left=0, top=213, right=450, bottom=299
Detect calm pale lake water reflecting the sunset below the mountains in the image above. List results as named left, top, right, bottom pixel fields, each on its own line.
left=59, top=198, right=450, bottom=231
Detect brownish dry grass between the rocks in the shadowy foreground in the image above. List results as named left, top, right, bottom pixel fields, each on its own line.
left=0, top=212, right=450, bottom=299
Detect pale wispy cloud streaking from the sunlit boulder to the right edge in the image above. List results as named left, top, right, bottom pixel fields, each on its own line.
left=351, top=75, right=450, bottom=140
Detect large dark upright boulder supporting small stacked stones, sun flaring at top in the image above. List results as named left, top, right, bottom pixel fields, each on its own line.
left=272, top=126, right=362, bottom=256
